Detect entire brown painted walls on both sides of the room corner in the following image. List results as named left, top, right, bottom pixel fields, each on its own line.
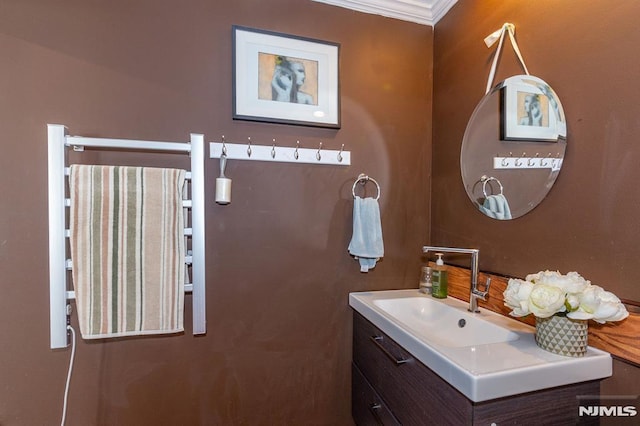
left=0, top=0, right=640, bottom=425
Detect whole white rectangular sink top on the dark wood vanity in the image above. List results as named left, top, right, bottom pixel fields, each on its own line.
left=349, top=290, right=612, bottom=402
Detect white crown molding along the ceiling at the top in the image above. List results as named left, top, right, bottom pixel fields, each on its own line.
left=313, top=0, right=458, bottom=26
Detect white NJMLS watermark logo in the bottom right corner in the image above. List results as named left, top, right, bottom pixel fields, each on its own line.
left=578, top=395, right=638, bottom=424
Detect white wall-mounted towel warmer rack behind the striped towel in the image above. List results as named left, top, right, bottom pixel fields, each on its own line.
left=47, top=124, right=206, bottom=349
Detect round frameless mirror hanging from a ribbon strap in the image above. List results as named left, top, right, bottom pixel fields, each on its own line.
left=460, top=75, right=567, bottom=220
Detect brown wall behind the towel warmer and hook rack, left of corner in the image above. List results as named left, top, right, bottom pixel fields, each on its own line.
left=0, top=0, right=433, bottom=425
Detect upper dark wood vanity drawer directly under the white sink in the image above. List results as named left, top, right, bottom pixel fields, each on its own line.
left=353, top=312, right=473, bottom=426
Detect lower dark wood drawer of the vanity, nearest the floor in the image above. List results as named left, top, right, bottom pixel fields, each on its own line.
left=351, top=364, right=400, bottom=426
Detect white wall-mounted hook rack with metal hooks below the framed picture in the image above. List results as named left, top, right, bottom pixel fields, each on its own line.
left=209, top=138, right=351, bottom=166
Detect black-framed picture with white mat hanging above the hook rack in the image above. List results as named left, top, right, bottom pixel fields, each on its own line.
left=233, top=25, right=340, bottom=128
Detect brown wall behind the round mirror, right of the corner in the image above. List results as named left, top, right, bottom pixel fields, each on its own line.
left=431, top=0, right=640, bottom=402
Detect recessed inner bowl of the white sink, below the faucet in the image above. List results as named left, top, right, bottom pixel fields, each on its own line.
left=373, top=297, right=518, bottom=348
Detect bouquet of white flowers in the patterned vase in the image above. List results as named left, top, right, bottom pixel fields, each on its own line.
left=503, top=271, right=629, bottom=324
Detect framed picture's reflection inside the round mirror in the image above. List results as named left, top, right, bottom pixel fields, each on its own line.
left=500, top=77, right=567, bottom=142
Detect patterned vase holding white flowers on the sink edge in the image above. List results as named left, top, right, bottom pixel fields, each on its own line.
left=536, top=315, right=589, bottom=357
